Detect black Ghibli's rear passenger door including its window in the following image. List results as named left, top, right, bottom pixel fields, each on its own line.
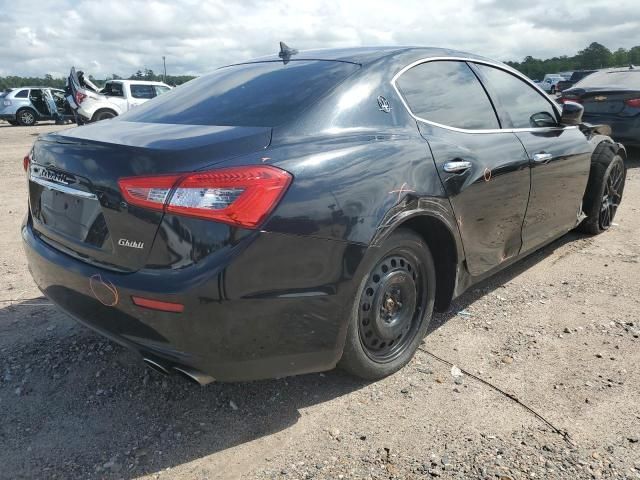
left=393, top=60, right=530, bottom=276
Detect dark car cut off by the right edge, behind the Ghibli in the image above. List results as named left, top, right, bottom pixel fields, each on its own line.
left=559, top=67, right=640, bottom=147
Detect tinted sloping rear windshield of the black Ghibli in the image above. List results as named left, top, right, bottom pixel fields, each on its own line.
left=121, top=60, right=359, bottom=127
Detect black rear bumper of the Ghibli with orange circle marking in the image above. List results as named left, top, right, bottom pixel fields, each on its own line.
left=22, top=221, right=366, bottom=381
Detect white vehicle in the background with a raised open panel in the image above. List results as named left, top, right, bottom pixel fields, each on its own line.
left=67, top=68, right=171, bottom=123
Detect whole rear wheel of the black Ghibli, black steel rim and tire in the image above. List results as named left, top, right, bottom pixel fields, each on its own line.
left=339, top=229, right=436, bottom=380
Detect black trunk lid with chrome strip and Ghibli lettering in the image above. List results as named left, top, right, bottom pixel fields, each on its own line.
left=29, top=120, right=271, bottom=272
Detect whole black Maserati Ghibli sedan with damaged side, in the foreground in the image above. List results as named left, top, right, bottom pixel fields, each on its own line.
left=22, top=47, right=626, bottom=383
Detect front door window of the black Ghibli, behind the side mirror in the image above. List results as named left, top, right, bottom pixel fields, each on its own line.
left=475, top=64, right=557, bottom=128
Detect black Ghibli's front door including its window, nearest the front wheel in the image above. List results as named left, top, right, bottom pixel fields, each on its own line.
left=473, top=63, right=591, bottom=251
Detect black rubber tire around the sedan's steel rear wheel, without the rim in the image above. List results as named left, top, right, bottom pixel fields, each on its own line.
left=339, top=229, right=436, bottom=380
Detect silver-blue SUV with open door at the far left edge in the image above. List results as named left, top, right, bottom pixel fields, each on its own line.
left=0, top=87, right=74, bottom=126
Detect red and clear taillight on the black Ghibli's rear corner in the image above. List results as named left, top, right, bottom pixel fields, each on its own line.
left=118, top=165, right=292, bottom=228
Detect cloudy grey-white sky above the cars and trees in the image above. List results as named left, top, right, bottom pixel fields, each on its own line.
left=0, top=0, right=640, bottom=78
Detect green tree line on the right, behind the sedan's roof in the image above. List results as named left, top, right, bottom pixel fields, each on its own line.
left=505, top=42, right=640, bottom=80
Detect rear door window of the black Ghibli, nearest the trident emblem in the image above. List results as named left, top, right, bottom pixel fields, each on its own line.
left=396, top=61, right=500, bottom=130
